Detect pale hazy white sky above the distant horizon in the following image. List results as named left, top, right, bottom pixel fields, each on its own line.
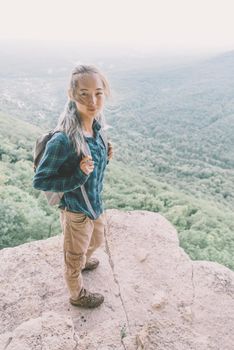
left=0, top=0, right=234, bottom=51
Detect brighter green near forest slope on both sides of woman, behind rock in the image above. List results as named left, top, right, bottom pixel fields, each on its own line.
left=0, top=109, right=234, bottom=269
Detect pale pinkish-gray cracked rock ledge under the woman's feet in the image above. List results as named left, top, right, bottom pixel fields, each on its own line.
left=0, top=210, right=234, bottom=350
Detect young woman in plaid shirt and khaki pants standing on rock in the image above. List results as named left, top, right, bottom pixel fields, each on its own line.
left=33, top=65, right=113, bottom=308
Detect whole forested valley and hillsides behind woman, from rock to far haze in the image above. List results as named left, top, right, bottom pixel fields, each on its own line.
left=0, top=49, right=234, bottom=269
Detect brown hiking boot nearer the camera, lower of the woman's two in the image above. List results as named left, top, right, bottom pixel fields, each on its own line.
left=69, top=288, right=104, bottom=308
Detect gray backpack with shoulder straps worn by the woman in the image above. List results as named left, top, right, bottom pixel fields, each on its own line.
left=33, top=130, right=108, bottom=209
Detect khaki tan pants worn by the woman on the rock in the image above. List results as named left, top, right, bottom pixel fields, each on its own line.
left=60, top=209, right=105, bottom=299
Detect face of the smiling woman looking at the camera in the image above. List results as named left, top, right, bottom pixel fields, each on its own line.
left=75, top=73, right=105, bottom=118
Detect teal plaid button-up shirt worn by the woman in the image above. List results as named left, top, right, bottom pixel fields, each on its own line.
left=33, top=120, right=108, bottom=219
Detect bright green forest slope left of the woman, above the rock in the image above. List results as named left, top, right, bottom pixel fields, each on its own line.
left=0, top=113, right=59, bottom=248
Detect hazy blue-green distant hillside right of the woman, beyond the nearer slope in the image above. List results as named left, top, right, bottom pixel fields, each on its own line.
left=109, top=53, right=234, bottom=208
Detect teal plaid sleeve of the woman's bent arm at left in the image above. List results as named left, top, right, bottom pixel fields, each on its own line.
left=33, top=137, right=89, bottom=192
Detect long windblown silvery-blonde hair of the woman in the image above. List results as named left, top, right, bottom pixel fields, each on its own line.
left=54, top=64, right=110, bottom=154
